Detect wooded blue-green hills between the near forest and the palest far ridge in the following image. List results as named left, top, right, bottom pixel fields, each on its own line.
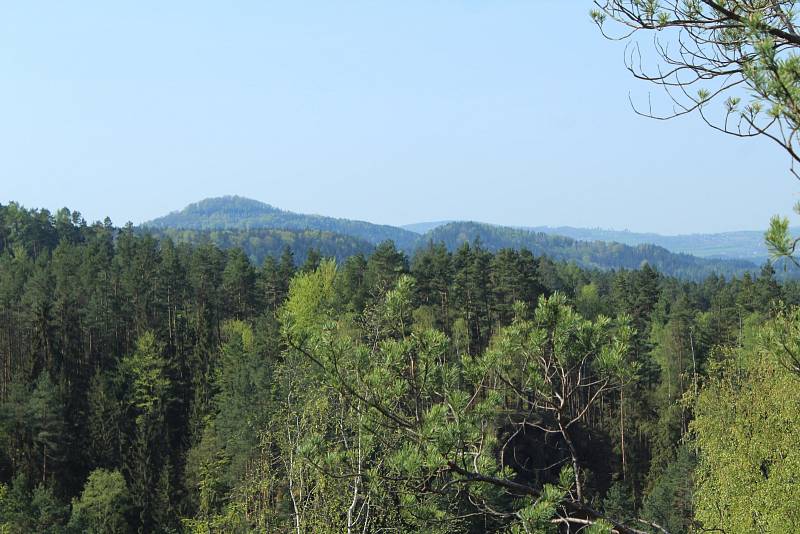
left=142, top=197, right=764, bottom=281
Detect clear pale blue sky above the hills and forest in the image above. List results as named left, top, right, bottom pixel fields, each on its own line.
left=0, top=0, right=800, bottom=234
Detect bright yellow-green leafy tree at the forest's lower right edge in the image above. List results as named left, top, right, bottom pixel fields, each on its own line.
left=692, top=311, right=800, bottom=533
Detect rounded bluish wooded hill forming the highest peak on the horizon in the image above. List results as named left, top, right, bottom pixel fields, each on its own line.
left=142, top=196, right=418, bottom=249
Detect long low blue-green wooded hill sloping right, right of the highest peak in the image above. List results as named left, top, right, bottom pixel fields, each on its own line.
left=422, top=222, right=757, bottom=280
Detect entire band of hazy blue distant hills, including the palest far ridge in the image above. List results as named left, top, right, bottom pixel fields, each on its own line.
left=142, top=196, right=766, bottom=279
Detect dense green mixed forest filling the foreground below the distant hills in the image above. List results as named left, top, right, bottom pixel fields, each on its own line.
left=0, top=204, right=800, bottom=534
